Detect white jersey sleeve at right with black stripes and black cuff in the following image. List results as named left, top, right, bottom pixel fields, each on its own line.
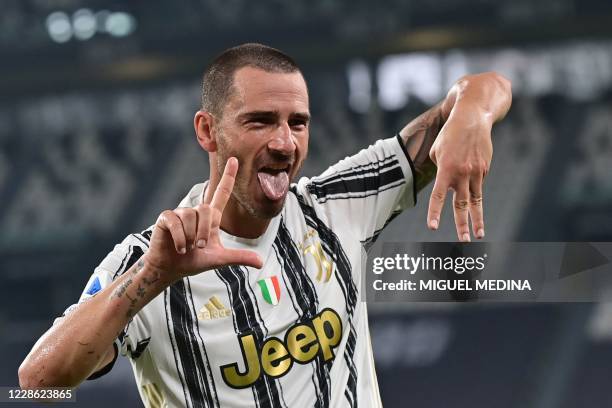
left=298, top=134, right=416, bottom=244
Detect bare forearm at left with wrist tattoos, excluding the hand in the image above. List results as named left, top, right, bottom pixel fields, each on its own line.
left=19, top=257, right=171, bottom=388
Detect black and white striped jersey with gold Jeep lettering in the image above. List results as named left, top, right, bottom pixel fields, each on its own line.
left=64, top=137, right=415, bottom=408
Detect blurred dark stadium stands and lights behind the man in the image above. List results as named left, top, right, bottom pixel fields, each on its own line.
left=0, top=0, right=612, bottom=408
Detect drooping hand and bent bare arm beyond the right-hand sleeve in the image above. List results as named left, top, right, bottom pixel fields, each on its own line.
left=400, top=72, right=512, bottom=242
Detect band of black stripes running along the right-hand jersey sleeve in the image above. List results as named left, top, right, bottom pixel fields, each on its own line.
left=307, top=159, right=406, bottom=202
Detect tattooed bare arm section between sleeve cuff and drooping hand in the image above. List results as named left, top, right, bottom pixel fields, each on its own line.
left=400, top=103, right=446, bottom=191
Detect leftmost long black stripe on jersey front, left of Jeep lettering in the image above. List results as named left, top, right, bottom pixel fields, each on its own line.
left=170, top=278, right=218, bottom=408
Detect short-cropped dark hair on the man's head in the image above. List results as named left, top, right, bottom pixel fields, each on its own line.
left=202, top=43, right=301, bottom=117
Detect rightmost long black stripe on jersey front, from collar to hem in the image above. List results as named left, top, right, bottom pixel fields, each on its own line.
left=291, top=190, right=357, bottom=408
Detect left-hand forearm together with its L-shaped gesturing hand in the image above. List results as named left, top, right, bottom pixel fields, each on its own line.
left=19, top=157, right=262, bottom=389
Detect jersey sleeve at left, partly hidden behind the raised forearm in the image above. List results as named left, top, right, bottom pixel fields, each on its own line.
left=56, top=229, right=151, bottom=380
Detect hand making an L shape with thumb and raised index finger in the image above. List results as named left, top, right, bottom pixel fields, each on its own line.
left=145, top=157, right=263, bottom=280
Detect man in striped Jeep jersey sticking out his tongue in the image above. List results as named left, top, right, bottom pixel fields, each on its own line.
left=19, top=44, right=511, bottom=407
